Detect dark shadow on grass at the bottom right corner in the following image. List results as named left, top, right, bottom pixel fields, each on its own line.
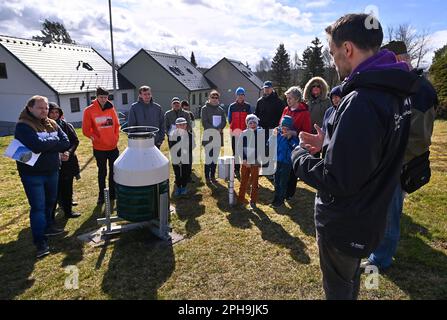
left=384, top=214, right=447, bottom=299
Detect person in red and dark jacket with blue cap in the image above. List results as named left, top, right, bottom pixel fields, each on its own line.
left=228, top=87, right=252, bottom=179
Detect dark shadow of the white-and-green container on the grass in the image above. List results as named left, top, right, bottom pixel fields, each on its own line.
left=102, top=229, right=175, bottom=299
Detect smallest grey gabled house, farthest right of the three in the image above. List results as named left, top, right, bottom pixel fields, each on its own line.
left=204, top=58, right=263, bottom=108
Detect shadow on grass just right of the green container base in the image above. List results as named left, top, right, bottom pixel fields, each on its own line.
left=171, top=172, right=205, bottom=238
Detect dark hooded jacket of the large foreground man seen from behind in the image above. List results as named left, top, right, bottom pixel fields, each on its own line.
left=292, top=50, right=416, bottom=258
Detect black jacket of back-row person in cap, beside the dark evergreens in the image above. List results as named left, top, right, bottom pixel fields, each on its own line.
left=255, top=92, right=286, bottom=130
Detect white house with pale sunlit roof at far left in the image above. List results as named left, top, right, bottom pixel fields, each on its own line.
left=0, top=35, right=135, bottom=135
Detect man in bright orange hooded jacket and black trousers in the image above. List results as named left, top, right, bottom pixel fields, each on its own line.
left=82, top=87, right=120, bottom=205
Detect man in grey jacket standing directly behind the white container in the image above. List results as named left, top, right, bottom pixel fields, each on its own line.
left=128, top=86, right=165, bottom=149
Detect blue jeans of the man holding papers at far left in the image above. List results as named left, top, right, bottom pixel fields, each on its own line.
left=21, top=171, right=59, bottom=245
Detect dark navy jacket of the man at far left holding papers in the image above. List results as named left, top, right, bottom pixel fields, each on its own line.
left=14, top=107, right=70, bottom=176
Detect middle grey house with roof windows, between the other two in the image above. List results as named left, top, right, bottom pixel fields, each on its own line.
left=119, top=49, right=212, bottom=115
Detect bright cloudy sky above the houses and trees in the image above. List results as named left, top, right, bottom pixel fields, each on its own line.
left=0, top=0, right=447, bottom=69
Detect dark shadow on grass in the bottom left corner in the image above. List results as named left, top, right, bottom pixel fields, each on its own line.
left=0, top=227, right=36, bottom=300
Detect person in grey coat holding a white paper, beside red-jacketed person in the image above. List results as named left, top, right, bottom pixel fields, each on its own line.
left=201, top=90, right=227, bottom=183
